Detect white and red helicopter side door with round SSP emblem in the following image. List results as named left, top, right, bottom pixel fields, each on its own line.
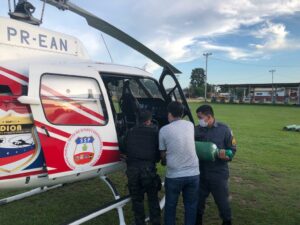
left=23, top=65, right=120, bottom=179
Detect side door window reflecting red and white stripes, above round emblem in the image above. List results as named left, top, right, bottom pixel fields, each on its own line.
left=40, top=74, right=107, bottom=126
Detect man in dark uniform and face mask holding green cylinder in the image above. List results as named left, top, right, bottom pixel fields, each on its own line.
left=195, top=105, right=236, bottom=225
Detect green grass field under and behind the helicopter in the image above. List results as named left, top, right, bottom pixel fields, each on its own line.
left=0, top=103, right=300, bottom=225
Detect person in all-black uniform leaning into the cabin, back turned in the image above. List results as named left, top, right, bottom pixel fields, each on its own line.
left=123, top=111, right=161, bottom=225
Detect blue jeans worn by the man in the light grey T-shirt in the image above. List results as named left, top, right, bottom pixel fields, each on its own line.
left=164, top=175, right=199, bottom=225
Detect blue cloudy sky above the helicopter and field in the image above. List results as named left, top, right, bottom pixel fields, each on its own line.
left=0, top=0, right=300, bottom=87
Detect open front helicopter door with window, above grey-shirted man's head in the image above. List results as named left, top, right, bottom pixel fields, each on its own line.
left=159, top=69, right=194, bottom=123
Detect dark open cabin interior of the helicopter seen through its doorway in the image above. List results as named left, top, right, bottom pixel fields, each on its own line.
left=101, top=73, right=191, bottom=137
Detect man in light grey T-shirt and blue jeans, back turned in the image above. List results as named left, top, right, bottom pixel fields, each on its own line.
left=159, top=102, right=199, bottom=225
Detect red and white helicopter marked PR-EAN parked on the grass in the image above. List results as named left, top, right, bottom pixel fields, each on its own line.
left=0, top=0, right=193, bottom=224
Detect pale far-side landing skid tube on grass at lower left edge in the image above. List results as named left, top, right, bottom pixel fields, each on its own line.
left=0, top=184, right=63, bottom=205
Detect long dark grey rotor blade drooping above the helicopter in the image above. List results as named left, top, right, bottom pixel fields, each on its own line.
left=43, top=0, right=181, bottom=73
